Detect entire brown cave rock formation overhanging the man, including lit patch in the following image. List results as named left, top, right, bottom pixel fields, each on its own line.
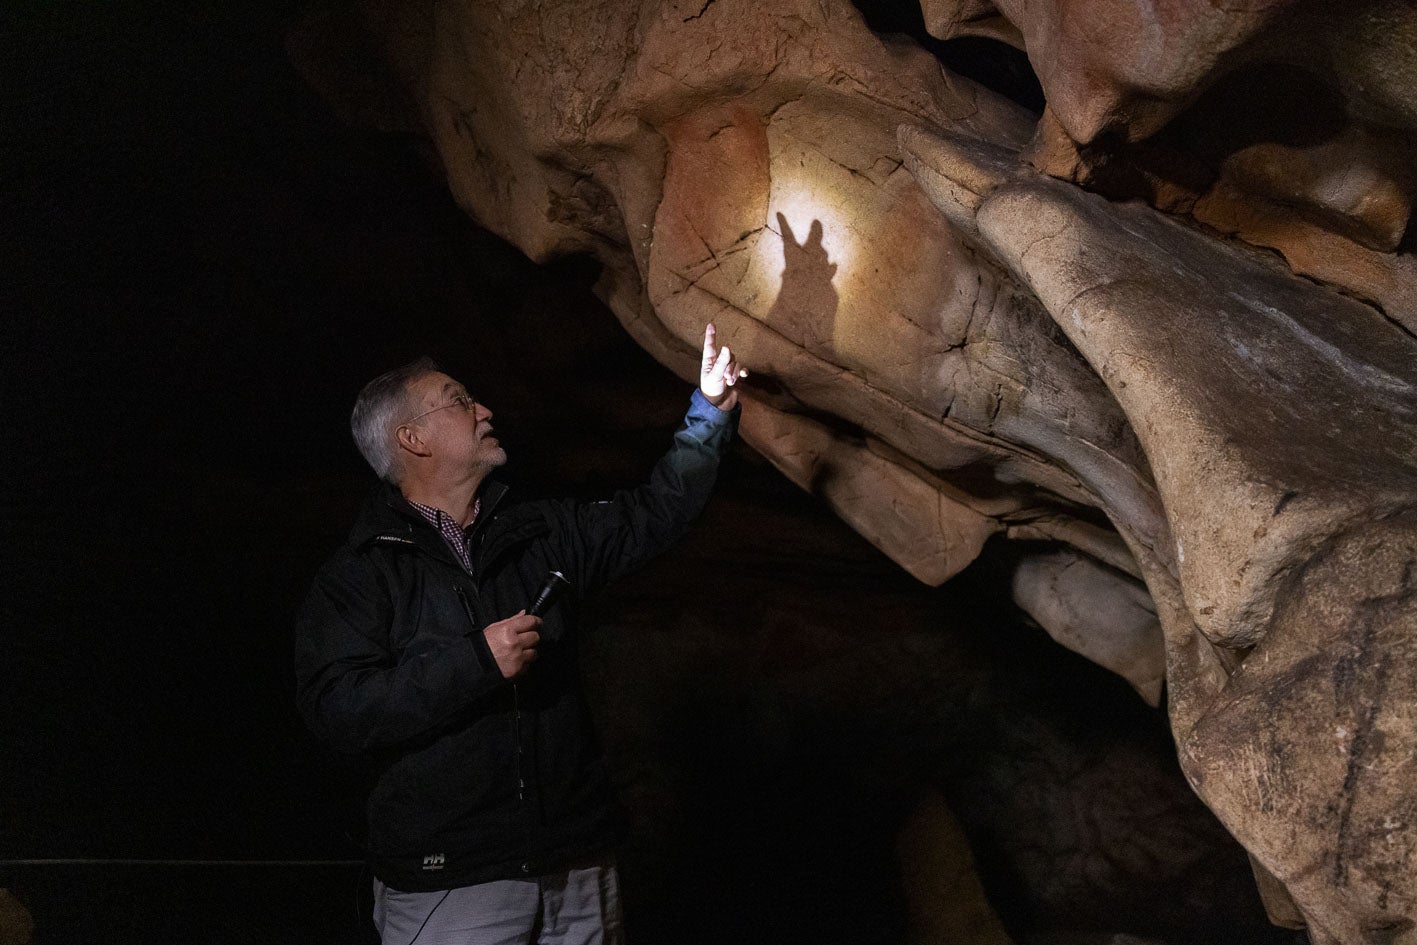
left=293, top=0, right=1417, bottom=945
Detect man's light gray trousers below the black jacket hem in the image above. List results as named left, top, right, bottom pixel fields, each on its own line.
left=374, top=863, right=625, bottom=945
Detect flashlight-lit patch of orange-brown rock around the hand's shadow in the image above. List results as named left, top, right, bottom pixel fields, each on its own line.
left=652, top=102, right=978, bottom=404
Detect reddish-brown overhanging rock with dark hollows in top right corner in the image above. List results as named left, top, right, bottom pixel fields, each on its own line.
left=924, top=0, right=1417, bottom=283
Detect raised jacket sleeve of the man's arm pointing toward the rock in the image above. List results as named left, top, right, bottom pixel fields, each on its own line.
left=558, top=390, right=740, bottom=594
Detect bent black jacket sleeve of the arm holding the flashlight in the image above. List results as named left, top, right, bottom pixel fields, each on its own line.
left=295, top=550, right=504, bottom=754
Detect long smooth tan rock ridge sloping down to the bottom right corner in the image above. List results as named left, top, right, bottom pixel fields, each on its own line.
left=914, top=127, right=1417, bottom=942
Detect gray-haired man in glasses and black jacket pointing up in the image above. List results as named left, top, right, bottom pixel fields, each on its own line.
left=296, top=324, right=747, bottom=945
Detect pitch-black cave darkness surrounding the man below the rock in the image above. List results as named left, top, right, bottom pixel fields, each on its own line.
left=0, top=0, right=1288, bottom=945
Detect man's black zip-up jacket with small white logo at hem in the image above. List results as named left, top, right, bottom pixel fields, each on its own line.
left=296, top=391, right=737, bottom=891
